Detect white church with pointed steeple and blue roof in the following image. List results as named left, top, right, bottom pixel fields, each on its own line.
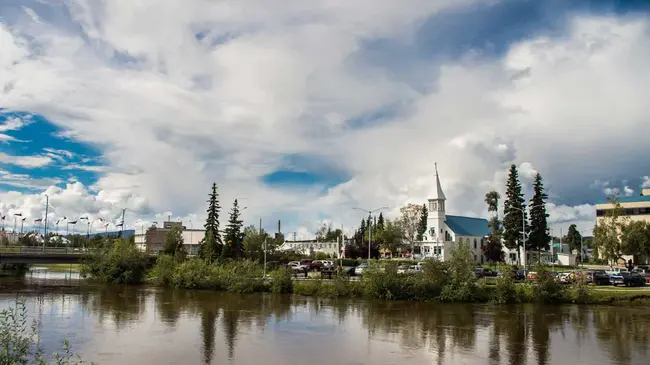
left=417, top=166, right=489, bottom=263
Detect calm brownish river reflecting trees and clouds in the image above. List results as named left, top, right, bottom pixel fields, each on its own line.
left=0, top=273, right=650, bottom=365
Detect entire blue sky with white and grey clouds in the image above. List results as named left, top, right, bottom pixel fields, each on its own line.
left=0, top=0, right=650, bottom=239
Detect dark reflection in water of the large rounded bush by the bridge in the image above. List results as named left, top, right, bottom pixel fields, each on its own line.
left=80, top=285, right=147, bottom=330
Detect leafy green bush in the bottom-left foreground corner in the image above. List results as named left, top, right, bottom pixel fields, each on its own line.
left=0, top=300, right=92, bottom=365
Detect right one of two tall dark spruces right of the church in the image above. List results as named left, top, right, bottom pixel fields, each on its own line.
left=526, top=173, right=551, bottom=258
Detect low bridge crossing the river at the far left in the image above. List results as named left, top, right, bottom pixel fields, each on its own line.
left=0, top=246, right=156, bottom=264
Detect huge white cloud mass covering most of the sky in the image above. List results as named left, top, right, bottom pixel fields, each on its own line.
left=0, top=0, right=650, bottom=236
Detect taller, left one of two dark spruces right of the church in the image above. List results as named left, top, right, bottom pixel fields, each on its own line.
left=503, top=165, right=526, bottom=263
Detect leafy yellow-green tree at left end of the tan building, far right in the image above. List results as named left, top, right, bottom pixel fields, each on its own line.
left=594, top=195, right=627, bottom=262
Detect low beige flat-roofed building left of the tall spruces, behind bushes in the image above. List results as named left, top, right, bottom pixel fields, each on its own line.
left=135, top=222, right=205, bottom=255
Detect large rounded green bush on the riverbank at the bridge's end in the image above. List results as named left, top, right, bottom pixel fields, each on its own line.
left=81, top=239, right=147, bottom=284
